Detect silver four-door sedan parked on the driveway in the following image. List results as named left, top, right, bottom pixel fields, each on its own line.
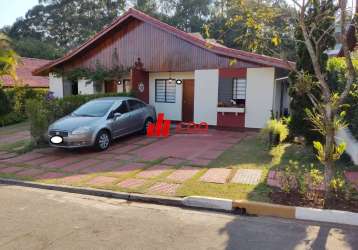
left=48, top=97, right=156, bottom=150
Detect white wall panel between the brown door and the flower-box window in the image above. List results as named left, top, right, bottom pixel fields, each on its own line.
left=194, top=69, right=219, bottom=125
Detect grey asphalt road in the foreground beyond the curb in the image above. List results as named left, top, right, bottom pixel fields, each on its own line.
left=0, top=186, right=358, bottom=250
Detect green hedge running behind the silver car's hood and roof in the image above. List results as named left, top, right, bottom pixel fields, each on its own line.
left=26, top=93, right=130, bottom=144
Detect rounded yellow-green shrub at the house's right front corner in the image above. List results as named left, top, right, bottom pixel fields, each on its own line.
left=262, top=119, right=289, bottom=145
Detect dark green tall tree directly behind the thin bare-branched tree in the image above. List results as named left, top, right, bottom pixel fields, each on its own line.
left=290, top=1, right=337, bottom=143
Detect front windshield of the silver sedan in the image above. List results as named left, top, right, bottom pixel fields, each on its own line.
left=72, top=101, right=114, bottom=117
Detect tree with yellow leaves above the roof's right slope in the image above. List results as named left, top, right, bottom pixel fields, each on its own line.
left=209, top=0, right=295, bottom=60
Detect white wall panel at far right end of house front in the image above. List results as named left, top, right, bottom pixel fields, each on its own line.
left=245, top=68, right=275, bottom=128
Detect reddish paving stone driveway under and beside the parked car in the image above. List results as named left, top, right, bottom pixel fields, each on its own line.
left=0, top=130, right=260, bottom=195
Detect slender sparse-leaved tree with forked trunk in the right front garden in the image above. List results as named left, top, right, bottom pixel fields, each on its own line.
left=293, top=0, right=355, bottom=199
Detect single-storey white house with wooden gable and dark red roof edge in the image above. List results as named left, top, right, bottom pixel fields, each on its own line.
left=33, top=9, right=294, bottom=128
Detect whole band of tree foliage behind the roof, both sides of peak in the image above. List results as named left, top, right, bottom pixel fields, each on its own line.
left=3, top=0, right=294, bottom=59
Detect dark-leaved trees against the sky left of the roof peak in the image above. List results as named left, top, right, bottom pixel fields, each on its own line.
left=8, top=0, right=125, bottom=50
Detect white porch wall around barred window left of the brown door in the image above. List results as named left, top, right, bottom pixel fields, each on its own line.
left=149, top=72, right=194, bottom=121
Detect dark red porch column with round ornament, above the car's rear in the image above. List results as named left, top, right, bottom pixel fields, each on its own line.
left=131, top=58, right=149, bottom=103
